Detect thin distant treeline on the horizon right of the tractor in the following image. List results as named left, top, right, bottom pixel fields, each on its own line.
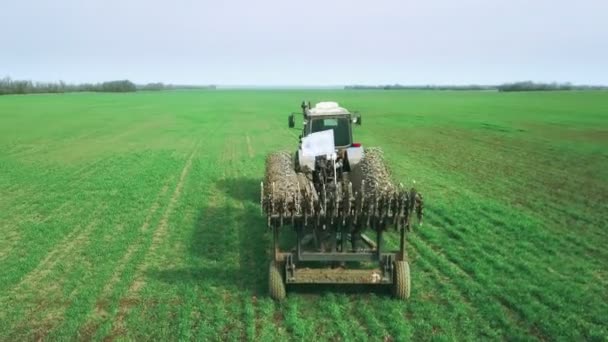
left=344, top=81, right=608, bottom=92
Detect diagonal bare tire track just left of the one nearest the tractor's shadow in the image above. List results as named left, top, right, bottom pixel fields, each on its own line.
left=80, top=177, right=173, bottom=339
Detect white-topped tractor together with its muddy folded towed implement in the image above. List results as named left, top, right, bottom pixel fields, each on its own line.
left=260, top=102, right=423, bottom=300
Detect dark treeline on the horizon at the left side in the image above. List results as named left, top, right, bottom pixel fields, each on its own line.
left=0, top=77, right=216, bottom=95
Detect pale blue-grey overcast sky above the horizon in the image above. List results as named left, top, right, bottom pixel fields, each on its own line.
left=0, top=0, right=608, bottom=85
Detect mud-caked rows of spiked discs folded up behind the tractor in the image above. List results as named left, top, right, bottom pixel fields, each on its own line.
left=261, top=152, right=423, bottom=230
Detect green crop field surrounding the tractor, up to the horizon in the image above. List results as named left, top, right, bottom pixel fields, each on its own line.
left=0, top=90, right=608, bottom=341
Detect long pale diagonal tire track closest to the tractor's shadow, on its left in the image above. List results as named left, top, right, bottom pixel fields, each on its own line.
left=109, top=141, right=200, bottom=340
